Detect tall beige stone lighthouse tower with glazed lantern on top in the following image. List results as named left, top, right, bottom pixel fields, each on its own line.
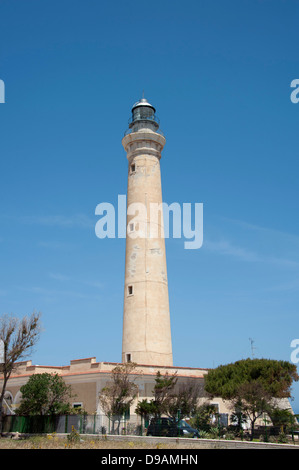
left=122, top=98, right=173, bottom=366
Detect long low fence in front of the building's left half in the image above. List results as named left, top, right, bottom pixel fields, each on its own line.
left=3, top=415, right=146, bottom=436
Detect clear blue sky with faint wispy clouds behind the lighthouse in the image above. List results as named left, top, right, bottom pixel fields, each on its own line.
left=0, top=0, right=299, bottom=412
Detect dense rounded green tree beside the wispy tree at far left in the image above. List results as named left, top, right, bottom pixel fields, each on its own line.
left=18, top=373, right=73, bottom=416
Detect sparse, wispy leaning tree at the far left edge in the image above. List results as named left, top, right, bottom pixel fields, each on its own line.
left=0, top=313, right=41, bottom=432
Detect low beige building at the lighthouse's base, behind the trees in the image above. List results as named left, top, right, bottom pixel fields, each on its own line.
left=0, top=357, right=216, bottom=416
